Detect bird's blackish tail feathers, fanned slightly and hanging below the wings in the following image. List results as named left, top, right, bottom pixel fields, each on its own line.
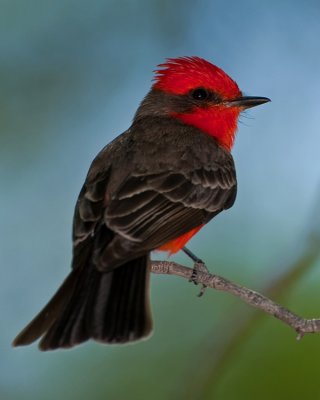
left=13, top=255, right=152, bottom=350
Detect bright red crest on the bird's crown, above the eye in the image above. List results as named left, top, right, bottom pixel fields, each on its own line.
left=153, top=57, right=241, bottom=100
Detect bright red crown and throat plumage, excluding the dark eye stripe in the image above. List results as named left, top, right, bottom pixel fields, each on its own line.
left=153, top=57, right=241, bottom=150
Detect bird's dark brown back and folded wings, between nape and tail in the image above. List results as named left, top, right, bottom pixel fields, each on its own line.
left=74, top=117, right=236, bottom=270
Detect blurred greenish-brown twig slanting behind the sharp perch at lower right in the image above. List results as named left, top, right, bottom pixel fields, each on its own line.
left=181, top=241, right=320, bottom=400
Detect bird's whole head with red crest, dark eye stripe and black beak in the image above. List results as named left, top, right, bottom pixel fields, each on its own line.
left=141, top=57, right=270, bottom=150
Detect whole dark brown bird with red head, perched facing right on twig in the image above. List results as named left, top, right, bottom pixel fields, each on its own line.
left=13, top=57, right=269, bottom=350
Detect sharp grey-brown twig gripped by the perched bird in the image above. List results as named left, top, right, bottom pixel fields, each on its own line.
left=152, top=261, right=320, bottom=339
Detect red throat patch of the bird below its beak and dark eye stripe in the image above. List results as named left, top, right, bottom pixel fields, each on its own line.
left=171, top=106, right=240, bottom=151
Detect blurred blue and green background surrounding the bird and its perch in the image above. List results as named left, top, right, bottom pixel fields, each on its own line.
left=0, top=0, right=320, bottom=400
